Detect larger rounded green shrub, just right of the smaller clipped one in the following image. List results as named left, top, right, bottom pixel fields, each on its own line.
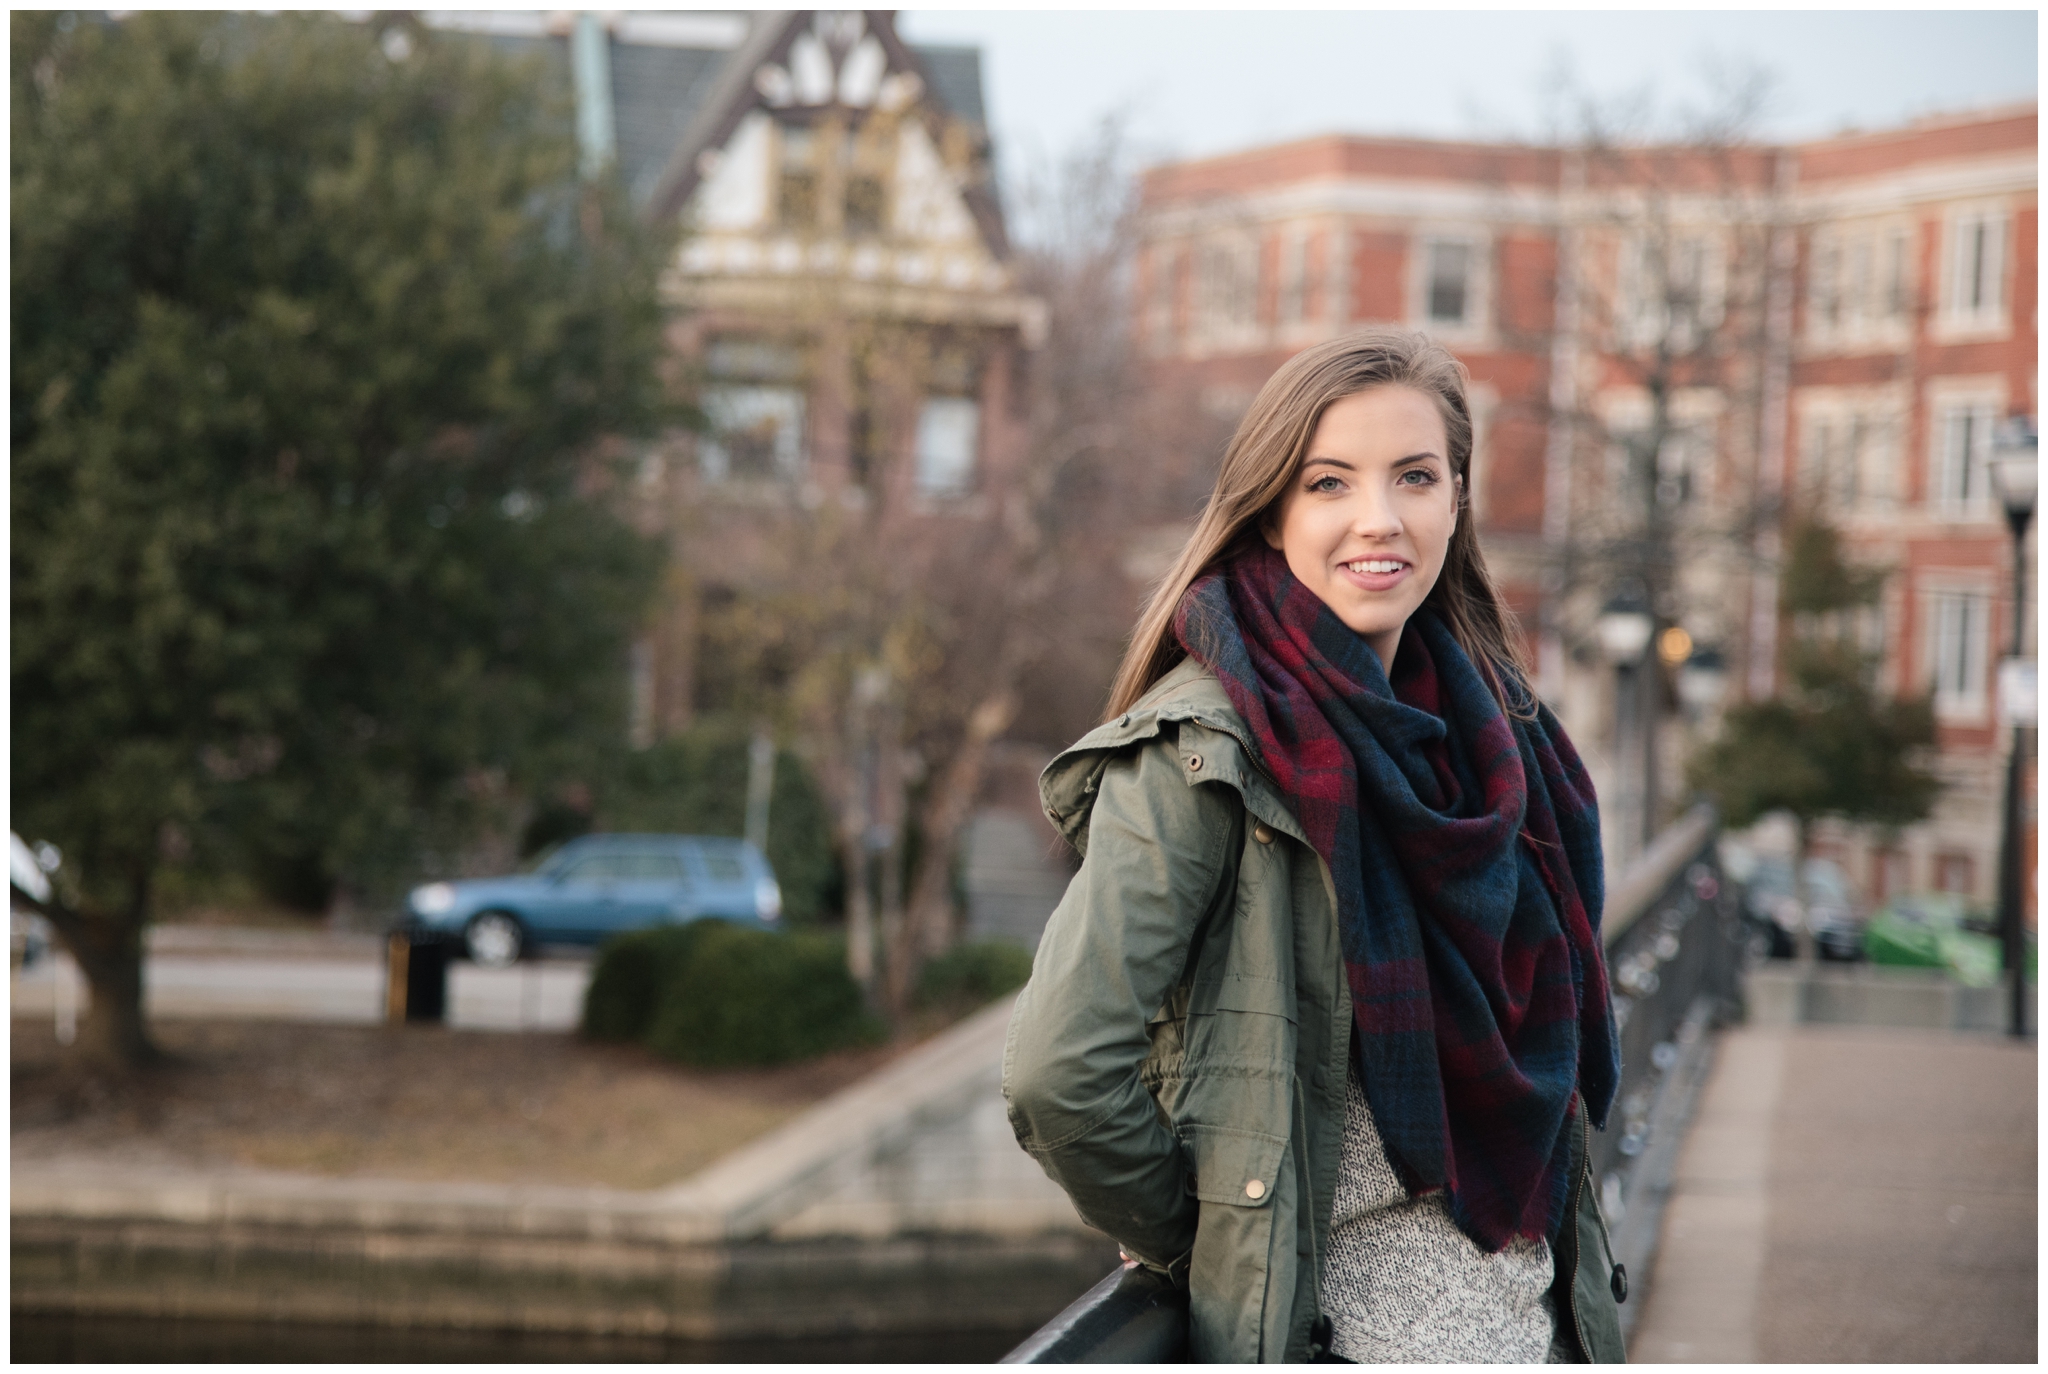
left=647, top=924, right=887, bottom=1069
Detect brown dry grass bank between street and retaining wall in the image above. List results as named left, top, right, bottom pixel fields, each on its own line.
left=12, top=1020, right=909, bottom=1190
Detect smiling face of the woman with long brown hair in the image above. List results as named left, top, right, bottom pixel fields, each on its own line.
left=1264, top=385, right=1458, bottom=672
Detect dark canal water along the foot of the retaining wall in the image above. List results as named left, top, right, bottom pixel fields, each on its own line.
left=8, top=1313, right=1030, bottom=1364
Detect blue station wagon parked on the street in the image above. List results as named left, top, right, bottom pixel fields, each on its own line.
left=401, top=835, right=782, bottom=969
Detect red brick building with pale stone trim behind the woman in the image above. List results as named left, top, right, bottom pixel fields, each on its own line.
left=1135, top=106, right=2038, bottom=899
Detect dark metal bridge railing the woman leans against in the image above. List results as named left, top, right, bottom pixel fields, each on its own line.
left=1001, top=807, right=1743, bottom=1364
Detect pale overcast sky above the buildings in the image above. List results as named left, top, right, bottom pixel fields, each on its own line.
left=897, top=10, right=2038, bottom=172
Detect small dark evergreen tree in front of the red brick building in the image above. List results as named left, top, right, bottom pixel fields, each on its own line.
left=1692, top=518, right=1942, bottom=941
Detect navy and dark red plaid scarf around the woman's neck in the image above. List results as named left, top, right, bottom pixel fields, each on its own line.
left=1174, top=545, right=1620, bottom=1251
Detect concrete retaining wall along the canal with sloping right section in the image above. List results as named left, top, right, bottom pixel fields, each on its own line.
left=12, top=997, right=1116, bottom=1341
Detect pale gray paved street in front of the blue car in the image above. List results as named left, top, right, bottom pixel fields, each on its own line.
left=10, top=932, right=590, bottom=1030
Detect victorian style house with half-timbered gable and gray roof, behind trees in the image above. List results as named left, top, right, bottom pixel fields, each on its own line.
left=428, top=10, right=1042, bottom=741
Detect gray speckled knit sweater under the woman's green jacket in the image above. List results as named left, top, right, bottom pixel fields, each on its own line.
left=1323, top=1063, right=1569, bottom=1364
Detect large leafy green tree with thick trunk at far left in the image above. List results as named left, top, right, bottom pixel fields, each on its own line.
left=10, top=12, right=666, bottom=1065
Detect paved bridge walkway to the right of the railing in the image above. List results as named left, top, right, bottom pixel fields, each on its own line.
left=1630, top=1026, right=2038, bottom=1364
